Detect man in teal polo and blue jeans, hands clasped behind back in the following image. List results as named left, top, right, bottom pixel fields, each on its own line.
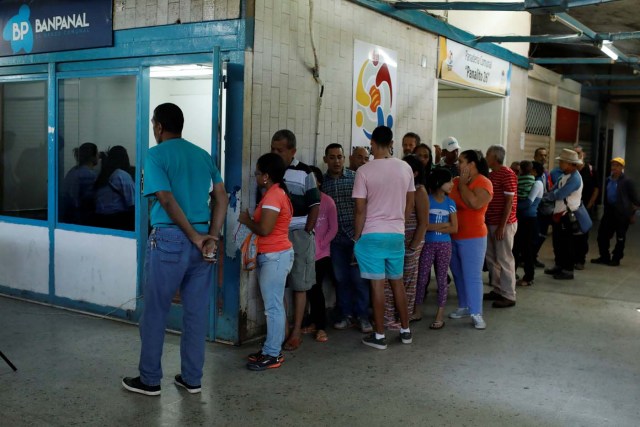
left=122, top=103, right=228, bottom=396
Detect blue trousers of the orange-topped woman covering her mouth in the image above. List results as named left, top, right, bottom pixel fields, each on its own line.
left=451, top=236, right=487, bottom=314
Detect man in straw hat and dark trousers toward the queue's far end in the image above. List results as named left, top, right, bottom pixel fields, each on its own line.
left=542, top=148, right=582, bottom=280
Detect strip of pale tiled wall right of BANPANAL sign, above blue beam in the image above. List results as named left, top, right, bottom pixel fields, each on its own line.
left=113, top=0, right=241, bottom=30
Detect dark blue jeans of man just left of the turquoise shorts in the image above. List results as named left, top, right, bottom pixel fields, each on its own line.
left=331, top=234, right=370, bottom=319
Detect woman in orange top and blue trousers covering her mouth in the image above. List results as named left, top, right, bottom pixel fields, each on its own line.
left=449, top=150, right=493, bottom=329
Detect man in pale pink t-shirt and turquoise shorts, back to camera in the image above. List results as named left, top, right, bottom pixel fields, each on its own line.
left=352, top=126, right=415, bottom=350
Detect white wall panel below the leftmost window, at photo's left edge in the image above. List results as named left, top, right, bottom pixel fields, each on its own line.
left=0, top=222, right=49, bottom=294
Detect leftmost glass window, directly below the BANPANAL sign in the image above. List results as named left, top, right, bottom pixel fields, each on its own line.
left=0, top=81, right=48, bottom=220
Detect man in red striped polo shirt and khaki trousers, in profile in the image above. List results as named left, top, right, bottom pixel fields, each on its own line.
left=484, top=145, right=518, bottom=308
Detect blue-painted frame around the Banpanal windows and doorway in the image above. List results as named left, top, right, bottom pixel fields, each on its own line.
left=0, top=20, right=245, bottom=343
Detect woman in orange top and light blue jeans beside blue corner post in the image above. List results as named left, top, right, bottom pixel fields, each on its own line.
left=238, top=153, right=293, bottom=371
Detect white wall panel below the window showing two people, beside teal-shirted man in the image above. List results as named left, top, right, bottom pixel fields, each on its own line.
left=55, top=230, right=137, bottom=309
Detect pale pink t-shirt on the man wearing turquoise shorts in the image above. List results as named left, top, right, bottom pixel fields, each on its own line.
left=351, top=157, right=416, bottom=234
